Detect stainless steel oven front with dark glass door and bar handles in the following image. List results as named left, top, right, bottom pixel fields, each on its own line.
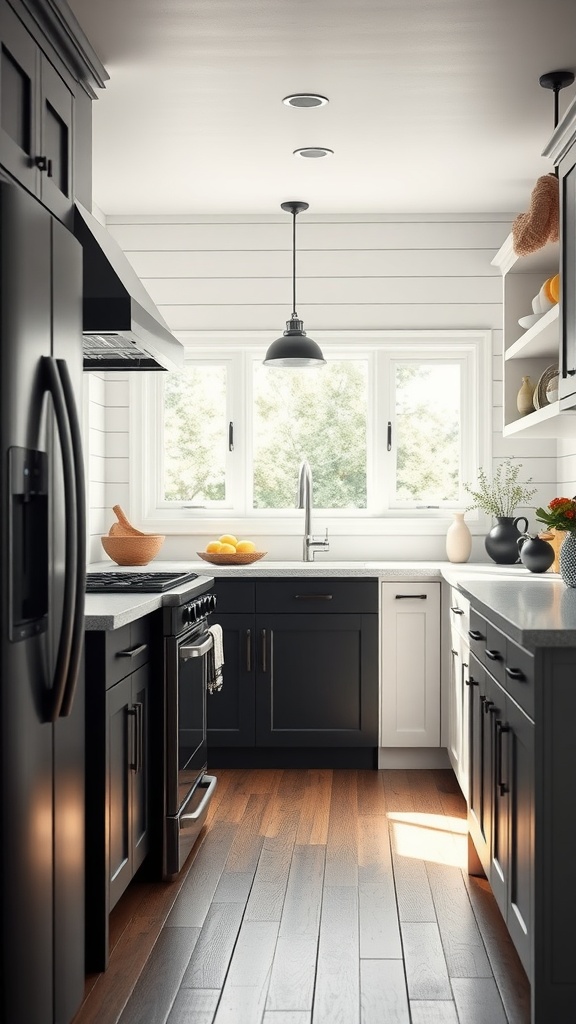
left=163, top=594, right=216, bottom=879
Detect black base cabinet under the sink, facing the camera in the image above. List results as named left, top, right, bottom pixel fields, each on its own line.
left=208, top=578, right=378, bottom=767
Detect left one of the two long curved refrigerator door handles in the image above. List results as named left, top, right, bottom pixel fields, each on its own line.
left=42, top=355, right=78, bottom=722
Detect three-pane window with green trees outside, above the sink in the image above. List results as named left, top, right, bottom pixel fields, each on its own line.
left=132, top=332, right=491, bottom=528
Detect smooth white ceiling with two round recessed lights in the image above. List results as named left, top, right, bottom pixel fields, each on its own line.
left=69, top=0, right=576, bottom=214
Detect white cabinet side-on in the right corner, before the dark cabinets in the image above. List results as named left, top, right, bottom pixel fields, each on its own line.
left=446, top=587, right=470, bottom=800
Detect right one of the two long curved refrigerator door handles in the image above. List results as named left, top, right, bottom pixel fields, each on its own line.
left=56, top=359, right=86, bottom=718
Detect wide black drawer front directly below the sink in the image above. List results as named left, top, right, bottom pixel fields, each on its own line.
left=256, top=577, right=378, bottom=614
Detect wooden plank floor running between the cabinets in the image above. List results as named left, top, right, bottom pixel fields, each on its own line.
left=74, top=769, right=530, bottom=1024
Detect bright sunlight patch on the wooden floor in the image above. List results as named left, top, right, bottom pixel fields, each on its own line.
left=387, top=811, right=467, bottom=868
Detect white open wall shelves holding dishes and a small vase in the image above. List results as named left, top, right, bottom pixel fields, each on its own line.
left=492, top=234, right=576, bottom=437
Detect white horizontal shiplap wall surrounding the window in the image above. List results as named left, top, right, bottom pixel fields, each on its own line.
left=85, top=214, right=557, bottom=558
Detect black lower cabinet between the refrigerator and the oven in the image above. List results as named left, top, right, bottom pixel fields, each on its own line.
left=86, top=616, right=154, bottom=971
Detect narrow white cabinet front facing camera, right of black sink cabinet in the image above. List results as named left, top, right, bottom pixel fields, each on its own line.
left=380, top=581, right=441, bottom=746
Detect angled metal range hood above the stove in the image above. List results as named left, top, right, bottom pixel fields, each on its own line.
left=74, top=203, right=184, bottom=371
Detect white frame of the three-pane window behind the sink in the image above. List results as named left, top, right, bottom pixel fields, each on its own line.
left=129, top=330, right=492, bottom=537
